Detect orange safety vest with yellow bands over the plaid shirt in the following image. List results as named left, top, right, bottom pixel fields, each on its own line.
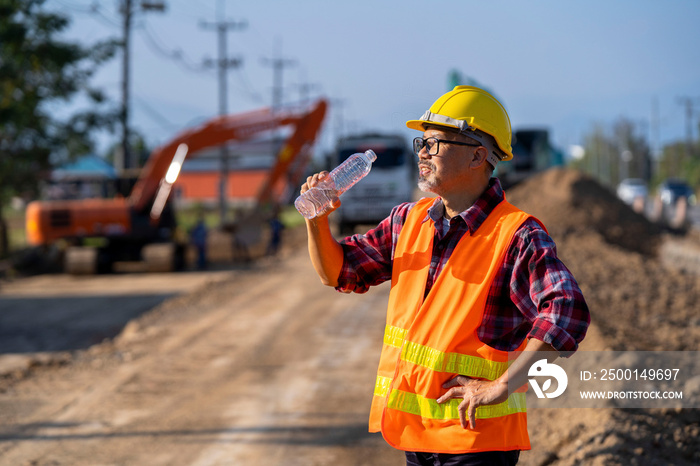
left=370, top=199, right=530, bottom=453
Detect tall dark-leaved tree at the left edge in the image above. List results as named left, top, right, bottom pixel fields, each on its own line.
left=0, top=0, right=118, bottom=256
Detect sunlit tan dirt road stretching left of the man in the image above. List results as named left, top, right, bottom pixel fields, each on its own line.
left=0, top=240, right=402, bottom=465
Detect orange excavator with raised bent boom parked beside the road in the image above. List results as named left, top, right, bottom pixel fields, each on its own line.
left=26, top=99, right=327, bottom=274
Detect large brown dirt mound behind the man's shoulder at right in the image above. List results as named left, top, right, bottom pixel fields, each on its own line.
left=507, top=169, right=700, bottom=466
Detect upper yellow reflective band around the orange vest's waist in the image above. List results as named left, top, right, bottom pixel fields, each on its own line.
left=384, top=325, right=508, bottom=380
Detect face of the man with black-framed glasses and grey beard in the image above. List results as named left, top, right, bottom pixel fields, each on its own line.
left=418, top=128, right=475, bottom=196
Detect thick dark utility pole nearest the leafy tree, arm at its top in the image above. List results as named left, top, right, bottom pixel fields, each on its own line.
left=119, top=0, right=165, bottom=173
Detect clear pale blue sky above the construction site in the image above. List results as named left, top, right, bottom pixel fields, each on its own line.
left=47, top=0, right=700, bottom=157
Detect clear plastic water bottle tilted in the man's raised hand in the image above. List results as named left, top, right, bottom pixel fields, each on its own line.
left=294, top=150, right=377, bottom=219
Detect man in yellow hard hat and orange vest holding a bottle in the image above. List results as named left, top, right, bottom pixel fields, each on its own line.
left=301, top=86, right=590, bottom=466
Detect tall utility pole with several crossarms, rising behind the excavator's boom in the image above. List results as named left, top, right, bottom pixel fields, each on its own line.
left=200, top=0, right=248, bottom=226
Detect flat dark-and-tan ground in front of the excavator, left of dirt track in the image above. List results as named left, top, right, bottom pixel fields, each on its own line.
left=0, top=271, right=235, bottom=356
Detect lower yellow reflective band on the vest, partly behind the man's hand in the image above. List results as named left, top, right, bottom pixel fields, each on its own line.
left=387, top=390, right=526, bottom=420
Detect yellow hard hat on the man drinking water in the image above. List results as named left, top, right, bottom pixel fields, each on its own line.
left=406, top=86, right=513, bottom=166
